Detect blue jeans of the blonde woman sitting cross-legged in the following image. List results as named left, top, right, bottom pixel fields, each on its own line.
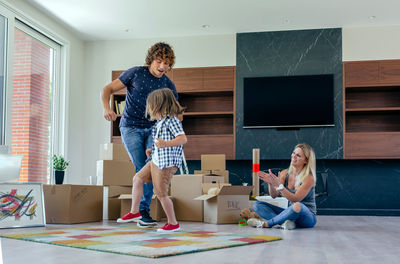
left=253, top=201, right=317, bottom=227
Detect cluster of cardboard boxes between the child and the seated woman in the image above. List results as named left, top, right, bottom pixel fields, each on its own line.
left=171, top=154, right=253, bottom=224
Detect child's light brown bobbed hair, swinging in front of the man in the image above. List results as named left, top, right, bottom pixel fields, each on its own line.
left=146, top=88, right=185, bottom=120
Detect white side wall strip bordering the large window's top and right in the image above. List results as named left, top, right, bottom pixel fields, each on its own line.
left=1, top=0, right=85, bottom=183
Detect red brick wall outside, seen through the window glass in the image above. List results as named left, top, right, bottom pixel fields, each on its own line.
left=11, top=29, right=51, bottom=183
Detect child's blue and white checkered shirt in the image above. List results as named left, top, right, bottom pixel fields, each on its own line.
left=152, top=116, right=185, bottom=170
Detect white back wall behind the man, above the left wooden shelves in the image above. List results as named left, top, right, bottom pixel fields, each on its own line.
left=81, top=35, right=236, bottom=181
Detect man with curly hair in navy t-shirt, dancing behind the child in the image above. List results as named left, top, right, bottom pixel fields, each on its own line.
left=101, top=42, right=178, bottom=227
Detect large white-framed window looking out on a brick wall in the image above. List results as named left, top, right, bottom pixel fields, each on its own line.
left=0, top=5, right=65, bottom=183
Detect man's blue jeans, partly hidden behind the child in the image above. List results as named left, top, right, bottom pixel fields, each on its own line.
left=119, top=127, right=153, bottom=212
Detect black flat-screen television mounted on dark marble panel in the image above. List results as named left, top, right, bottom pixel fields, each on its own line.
left=243, top=74, right=334, bottom=128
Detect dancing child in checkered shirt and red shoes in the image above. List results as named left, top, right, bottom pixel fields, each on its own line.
left=117, top=88, right=187, bottom=233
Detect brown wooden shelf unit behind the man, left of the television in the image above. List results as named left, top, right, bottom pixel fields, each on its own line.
left=111, top=66, right=236, bottom=160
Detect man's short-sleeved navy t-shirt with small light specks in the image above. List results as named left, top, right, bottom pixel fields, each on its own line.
left=119, top=66, right=178, bottom=128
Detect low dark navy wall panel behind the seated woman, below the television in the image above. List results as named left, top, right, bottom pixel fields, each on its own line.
left=188, top=159, right=400, bottom=216
